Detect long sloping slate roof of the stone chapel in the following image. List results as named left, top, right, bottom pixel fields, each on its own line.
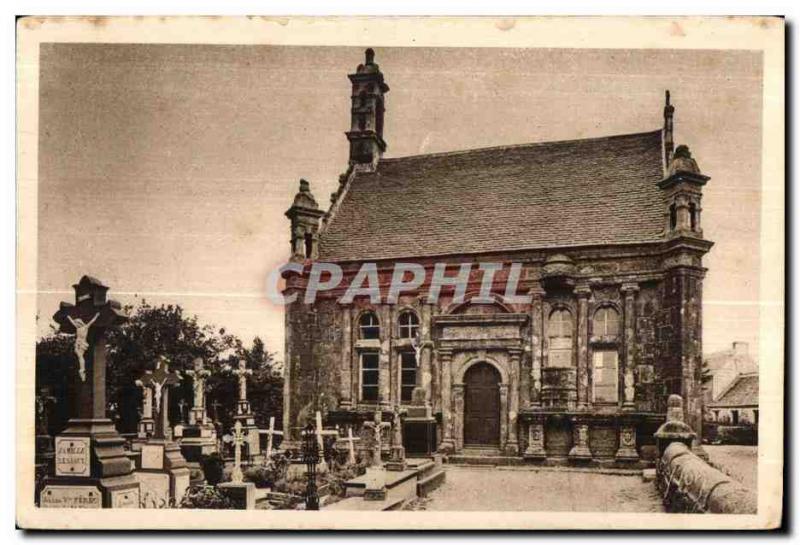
left=320, top=130, right=664, bottom=261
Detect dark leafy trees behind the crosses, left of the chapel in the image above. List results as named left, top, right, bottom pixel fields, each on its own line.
left=36, top=300, right=282, bottom=433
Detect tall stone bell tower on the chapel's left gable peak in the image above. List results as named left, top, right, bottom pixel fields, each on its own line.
left=345, top=49, right=389, bottom=165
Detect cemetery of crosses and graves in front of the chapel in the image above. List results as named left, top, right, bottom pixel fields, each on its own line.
left=35, top=276, right=756, bottom=513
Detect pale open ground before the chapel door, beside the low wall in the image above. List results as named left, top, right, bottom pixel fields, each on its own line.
left=424, top=466, right=664, bottom=513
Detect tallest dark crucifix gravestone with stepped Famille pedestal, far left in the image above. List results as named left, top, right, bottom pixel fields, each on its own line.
left=40, top=276, right=139, bottom=508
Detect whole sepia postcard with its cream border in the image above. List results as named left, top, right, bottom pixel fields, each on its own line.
left=15, top=17, right=784, bottom=530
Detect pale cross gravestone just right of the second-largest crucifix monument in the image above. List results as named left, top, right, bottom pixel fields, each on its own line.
left=181, top=358, right=217, bottom=467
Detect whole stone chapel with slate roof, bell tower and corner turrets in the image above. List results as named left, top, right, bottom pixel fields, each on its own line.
left=283, top=49, right=712, bottom=465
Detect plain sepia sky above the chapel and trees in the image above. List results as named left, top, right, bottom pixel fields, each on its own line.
left=38, top=44, right=761, bottom=353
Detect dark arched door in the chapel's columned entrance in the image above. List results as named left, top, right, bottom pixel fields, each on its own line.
left=464, top=363, right=500, bottom=446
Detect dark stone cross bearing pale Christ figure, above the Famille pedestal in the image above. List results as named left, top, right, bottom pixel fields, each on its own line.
left=53, top=276, right=128, bottom=419
